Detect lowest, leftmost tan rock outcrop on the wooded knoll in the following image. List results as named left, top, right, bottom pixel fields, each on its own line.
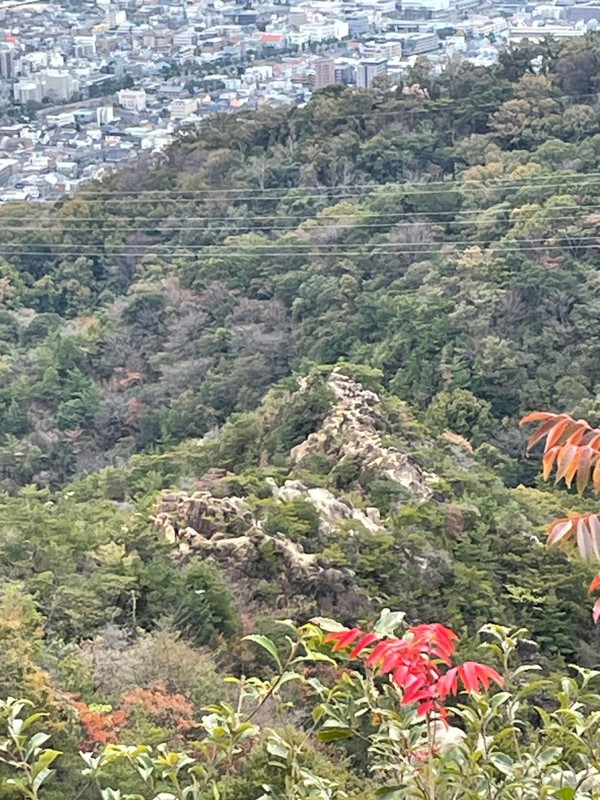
left=155, top=492, right=368, bottom=622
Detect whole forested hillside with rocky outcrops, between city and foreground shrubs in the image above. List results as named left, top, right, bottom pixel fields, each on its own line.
left=0, top=29, right=600, bottom=800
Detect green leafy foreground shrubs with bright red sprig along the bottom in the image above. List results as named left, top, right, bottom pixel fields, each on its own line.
left=8, top=620, right=600, bottom=800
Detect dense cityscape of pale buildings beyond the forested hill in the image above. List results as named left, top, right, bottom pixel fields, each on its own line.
left=0, top=0, right=600, bottom=202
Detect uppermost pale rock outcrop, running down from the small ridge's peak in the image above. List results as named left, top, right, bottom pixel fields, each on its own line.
left=291, top=369, right=435, bottom=500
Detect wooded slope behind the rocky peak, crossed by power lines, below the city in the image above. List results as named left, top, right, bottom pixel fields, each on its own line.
left=0, top=34, right=600, bottom=491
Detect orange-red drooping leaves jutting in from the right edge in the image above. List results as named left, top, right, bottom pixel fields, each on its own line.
left=520, top=411, right=600, bottom=623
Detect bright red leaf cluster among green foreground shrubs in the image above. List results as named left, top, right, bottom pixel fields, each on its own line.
left=325, top=622, right=503, bottom=719
